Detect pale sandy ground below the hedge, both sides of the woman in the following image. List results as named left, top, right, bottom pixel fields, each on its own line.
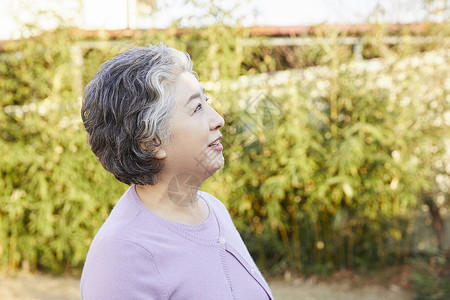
left=0, top=269, right=412, bottom=300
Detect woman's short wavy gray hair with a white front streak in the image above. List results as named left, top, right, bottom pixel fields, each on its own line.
left=81, top=43, right=195, bottom=185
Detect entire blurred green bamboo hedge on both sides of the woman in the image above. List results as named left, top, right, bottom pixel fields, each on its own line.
left=0, top=24, right=450, bottom=292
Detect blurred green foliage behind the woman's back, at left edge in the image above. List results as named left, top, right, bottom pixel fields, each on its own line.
left=0, top=31, right=129, bottom=272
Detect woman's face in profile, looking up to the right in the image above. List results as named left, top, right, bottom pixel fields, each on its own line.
left=164, top=72, right=224, bottom=182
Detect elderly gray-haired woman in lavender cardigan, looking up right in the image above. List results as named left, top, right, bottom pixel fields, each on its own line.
left=81, top=44, right=272, bottom=300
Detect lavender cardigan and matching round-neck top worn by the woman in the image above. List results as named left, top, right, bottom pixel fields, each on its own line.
left=81, top=185, right=273, bottom=300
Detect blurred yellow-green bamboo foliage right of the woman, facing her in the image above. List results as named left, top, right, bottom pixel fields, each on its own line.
left=205, top=37, right=450, bottom=274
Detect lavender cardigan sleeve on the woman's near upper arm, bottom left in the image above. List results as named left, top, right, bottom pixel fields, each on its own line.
left=81, top=239, right=169, bottom=300
